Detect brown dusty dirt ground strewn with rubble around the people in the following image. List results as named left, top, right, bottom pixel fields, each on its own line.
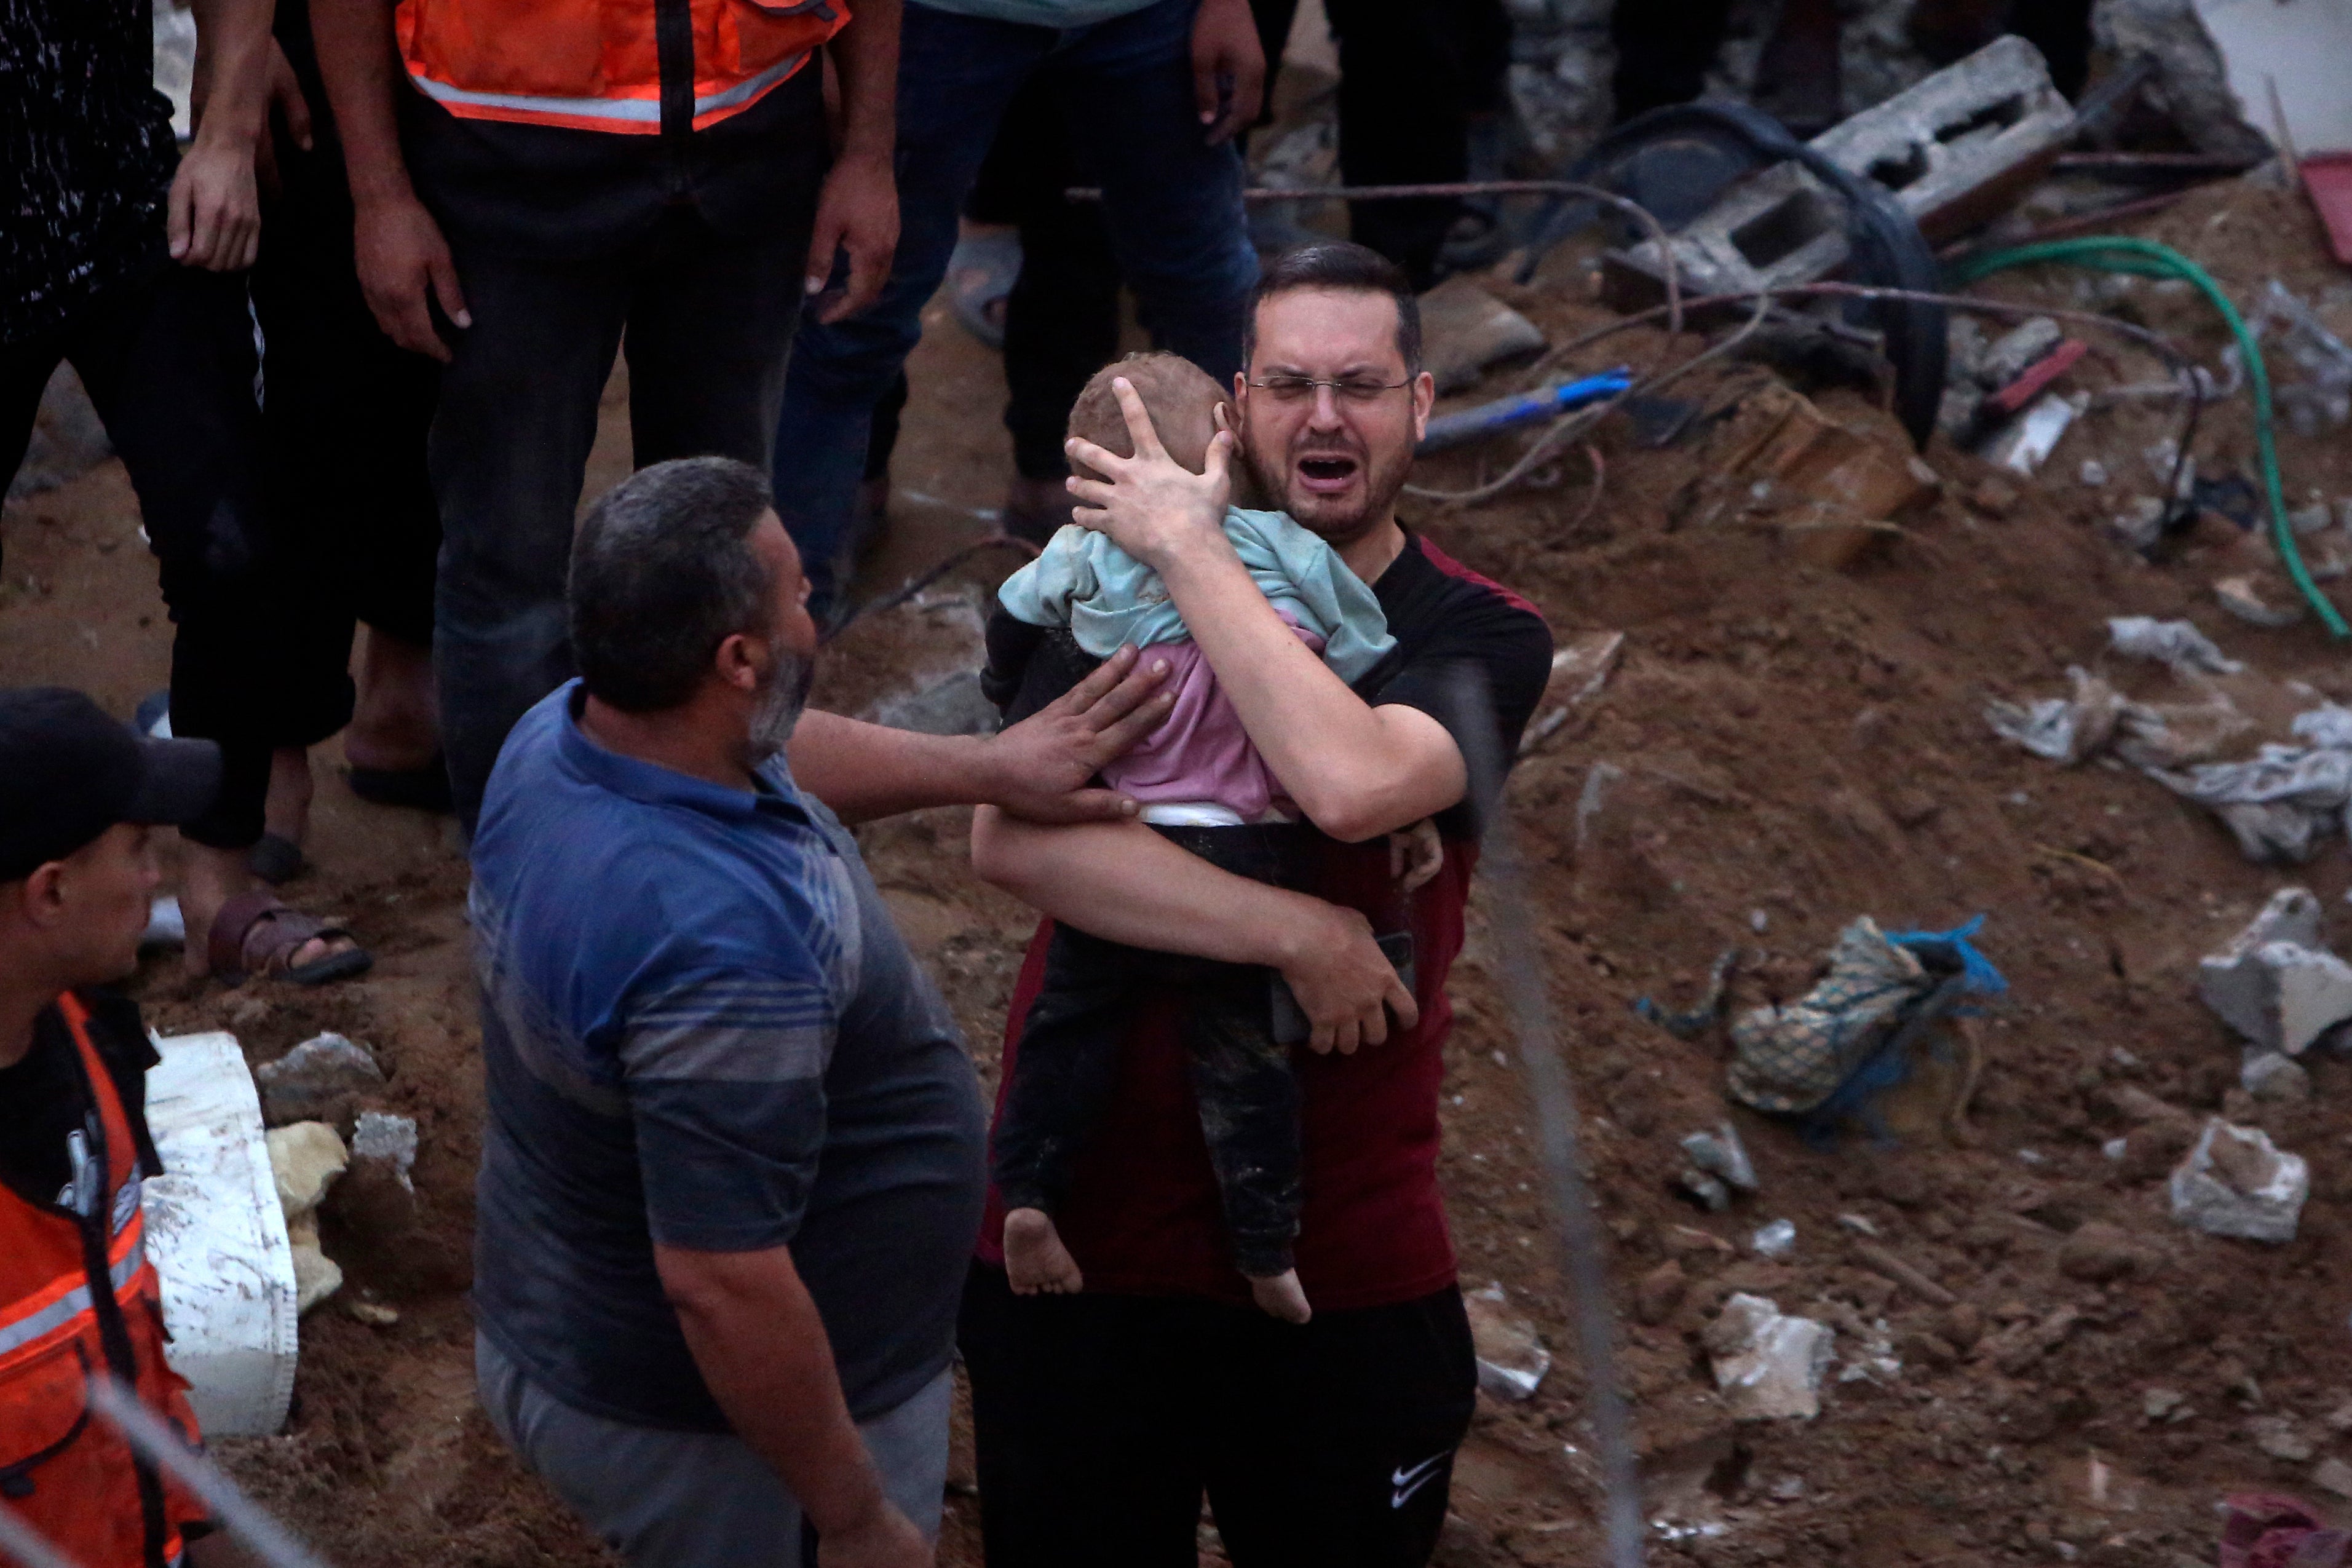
left=14, top=175, right=2352, bottom=1568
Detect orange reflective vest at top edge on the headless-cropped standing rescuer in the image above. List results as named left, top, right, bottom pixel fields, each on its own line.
left=395, top=0, right=849, bottom=134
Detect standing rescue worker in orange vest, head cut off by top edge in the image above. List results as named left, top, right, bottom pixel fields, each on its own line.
left=306, top=0, right=901, bottom=834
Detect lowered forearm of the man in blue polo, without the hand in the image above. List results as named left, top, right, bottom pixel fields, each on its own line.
left=654, top=1246, right=884, bottom=1535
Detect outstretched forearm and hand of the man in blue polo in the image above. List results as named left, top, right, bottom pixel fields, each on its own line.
left=788, top=649, right=1171, bottom=823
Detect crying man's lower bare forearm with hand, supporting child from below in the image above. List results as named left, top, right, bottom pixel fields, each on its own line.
left=972, top=806, right=1420, bottom=1053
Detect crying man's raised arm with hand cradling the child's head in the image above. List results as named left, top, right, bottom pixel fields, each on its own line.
left=1070, top=379, right=1470, bottom=844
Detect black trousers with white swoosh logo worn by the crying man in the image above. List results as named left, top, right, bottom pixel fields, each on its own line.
left=957, top=1265, right=1477, bottom=1568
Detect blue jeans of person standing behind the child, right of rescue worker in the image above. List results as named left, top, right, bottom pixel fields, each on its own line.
left=774, top=0, right=1258, bottom=616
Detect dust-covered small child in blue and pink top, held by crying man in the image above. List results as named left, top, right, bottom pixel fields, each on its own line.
left=990, top=355, right=1439, bottom=1321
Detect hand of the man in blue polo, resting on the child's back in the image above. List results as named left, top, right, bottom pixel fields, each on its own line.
left=981, top=646, right=1176, bottom=823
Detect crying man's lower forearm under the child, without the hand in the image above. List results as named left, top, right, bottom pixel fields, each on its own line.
left=972, top=806, right=1331, bottom=968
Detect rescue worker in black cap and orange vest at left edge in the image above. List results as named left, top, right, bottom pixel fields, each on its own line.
left=0, top=686, right=242, bottom=1568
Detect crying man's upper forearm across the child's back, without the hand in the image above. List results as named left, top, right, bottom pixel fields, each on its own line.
left=1162, top=540, right=1468, bottom=839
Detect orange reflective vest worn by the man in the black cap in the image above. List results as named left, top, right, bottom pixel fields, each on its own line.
left=0, top=994, right=205, bottom=1568
